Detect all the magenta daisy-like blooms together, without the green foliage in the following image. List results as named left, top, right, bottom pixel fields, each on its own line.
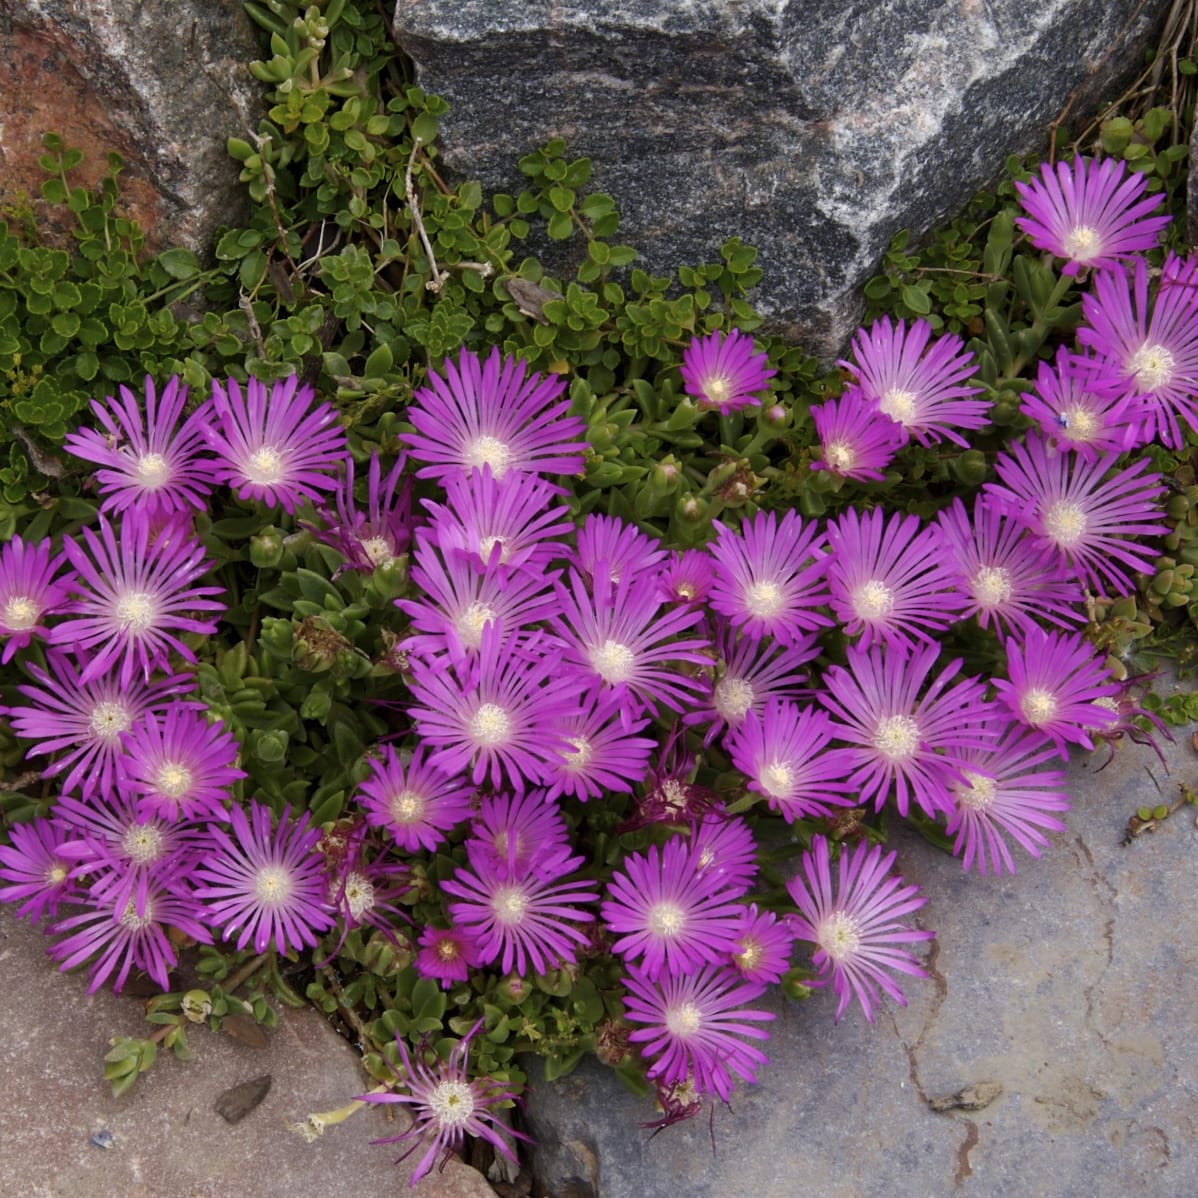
left=0, top=149, right=1178, bottom=1159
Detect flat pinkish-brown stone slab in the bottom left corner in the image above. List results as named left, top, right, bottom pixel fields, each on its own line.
left=0, top=907, right=495, bottom=1198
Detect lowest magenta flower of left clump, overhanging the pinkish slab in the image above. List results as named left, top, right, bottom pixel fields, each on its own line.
left=47, top=883, right=212, bottom=994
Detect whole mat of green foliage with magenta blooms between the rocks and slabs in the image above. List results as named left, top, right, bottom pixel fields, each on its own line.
left=0, top=0, right=1198, bottom=1176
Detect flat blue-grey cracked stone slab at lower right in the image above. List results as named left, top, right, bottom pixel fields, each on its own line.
left=527, top=714, right=1198, bottom=1198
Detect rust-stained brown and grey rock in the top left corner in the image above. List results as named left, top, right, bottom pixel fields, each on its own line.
left=0, top=0, right=260, bottom=252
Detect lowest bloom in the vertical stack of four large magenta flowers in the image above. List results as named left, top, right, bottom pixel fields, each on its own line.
left=409, top=621, right=574, bottom=791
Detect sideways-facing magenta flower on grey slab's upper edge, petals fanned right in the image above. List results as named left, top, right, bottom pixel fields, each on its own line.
left=944, top=724, right=1069, bottom=875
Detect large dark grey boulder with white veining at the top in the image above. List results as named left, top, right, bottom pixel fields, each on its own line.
left=394, top=0, right=1168, bottom=356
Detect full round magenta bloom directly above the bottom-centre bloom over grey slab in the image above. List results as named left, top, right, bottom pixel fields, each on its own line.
left=599, top=836, right=743, bottom=981
